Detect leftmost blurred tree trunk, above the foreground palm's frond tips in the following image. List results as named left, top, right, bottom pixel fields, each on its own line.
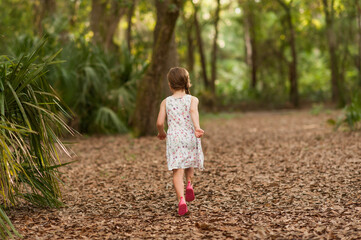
left=34, top=0, right=56, bottom=36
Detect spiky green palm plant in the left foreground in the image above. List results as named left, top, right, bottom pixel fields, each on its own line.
left=0, top=40, right=74, bottom=239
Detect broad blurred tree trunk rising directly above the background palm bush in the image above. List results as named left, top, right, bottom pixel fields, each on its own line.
left=90, top=0, right=127, bottom=50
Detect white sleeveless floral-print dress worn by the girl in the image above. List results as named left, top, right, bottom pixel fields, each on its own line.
left=166, top=94, right=204, bottom=170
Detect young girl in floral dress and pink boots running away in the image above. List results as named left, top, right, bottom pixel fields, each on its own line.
left=157, top=67, right=204, bottom=215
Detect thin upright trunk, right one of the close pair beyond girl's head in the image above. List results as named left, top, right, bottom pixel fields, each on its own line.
left=211, top=0, right=221, bottom=96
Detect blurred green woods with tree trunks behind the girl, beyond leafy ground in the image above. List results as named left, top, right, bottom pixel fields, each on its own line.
left=0, top=0, right=361, bottom=135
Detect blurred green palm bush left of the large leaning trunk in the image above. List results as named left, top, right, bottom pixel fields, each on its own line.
left=51, top=41, right=147, bottom=133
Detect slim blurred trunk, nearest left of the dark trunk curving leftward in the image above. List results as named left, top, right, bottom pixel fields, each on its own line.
left=243, top=0, right=258, bottom=89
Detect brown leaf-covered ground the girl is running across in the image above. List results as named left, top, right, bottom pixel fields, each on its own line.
left=9, top=111, right=361, bottom=239
